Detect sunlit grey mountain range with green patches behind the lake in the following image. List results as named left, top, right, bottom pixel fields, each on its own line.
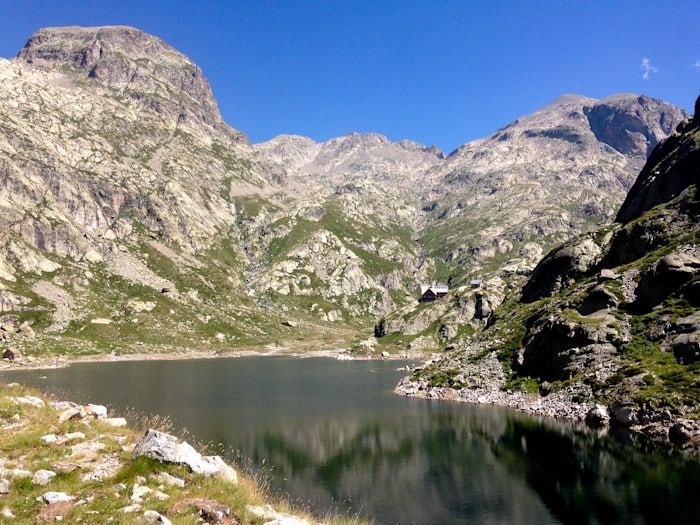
left=0, top=27, right=684, bottom=360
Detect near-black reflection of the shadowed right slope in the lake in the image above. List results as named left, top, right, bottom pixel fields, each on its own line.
left=494, top=419, right=700, bottom=523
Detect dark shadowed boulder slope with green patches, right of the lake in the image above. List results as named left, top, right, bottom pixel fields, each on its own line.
left=414, top=98, right=700, bottom=442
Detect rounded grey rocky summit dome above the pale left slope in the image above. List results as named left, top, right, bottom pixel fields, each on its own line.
left=17, top=26, right=243, bottom=140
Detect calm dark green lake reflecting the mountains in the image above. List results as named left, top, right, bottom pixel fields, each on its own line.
left=0, top=357, right=700, bottom=525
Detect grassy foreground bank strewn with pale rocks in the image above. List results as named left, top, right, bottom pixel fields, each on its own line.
left=0, top=383, right=356, bottom=525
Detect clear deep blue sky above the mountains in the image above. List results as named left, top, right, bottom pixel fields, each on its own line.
left=0, top=0, right=700, bottom=152
